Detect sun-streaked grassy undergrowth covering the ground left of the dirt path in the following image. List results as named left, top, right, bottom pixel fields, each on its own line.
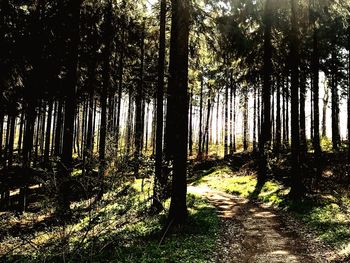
left=0, top=173, right=219, bottom=262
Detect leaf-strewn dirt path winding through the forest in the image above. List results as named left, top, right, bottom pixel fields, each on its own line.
left=188, top=186, right=332, bottom=263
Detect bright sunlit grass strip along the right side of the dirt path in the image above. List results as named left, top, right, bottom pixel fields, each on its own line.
left=194, top=164, right=350, bottom=256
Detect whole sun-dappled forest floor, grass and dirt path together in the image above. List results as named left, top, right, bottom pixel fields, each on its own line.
left=0, top=155, right=350, bottom=263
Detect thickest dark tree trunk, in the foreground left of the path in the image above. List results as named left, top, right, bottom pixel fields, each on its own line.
left=168, top=0, right=190, bottom=225
